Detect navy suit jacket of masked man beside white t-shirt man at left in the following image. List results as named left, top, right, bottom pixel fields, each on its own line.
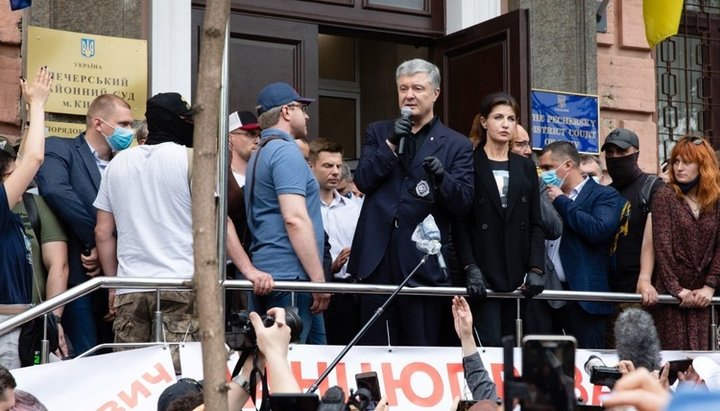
left=37, top=133, right=100, bottom=286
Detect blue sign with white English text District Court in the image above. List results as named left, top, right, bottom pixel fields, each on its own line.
left=528, top=90, right=600, bottom=154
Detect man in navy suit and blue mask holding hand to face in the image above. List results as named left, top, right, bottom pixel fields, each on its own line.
left=539, top=141, right=625, bottom=348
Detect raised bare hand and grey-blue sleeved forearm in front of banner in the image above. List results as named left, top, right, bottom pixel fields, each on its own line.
left=452, top=296, right=498, bottom=401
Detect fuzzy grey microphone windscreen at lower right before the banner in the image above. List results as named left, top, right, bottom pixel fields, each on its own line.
left=615, top=308, right=660, bottom=371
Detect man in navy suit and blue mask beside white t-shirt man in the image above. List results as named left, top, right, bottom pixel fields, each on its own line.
left=37, top=94, right=134, bottom=354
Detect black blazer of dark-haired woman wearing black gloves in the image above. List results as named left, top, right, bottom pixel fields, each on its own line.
left=453, top=147, right=545, bottom=292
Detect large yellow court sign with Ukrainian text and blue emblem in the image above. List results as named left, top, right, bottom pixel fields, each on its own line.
left=26, top=26, right=147, bottom=119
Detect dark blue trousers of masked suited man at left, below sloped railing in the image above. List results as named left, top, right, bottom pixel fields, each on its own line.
left=62, top=295, right=97, bottom=355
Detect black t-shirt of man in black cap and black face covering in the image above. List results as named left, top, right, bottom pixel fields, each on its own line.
left=608, top=173, right=664, bottom=293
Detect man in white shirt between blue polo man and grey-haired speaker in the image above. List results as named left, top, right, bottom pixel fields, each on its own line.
left=308, top=139, right=360, bottom=345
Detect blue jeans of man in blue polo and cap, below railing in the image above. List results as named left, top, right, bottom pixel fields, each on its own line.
left=248, top=291, right=327, bottom=345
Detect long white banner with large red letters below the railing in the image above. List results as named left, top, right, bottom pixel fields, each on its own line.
left=7, top=343, right=720, bottom=411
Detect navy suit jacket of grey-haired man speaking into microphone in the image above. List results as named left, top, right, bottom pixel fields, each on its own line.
left=348, top=121, right=473, bottom=285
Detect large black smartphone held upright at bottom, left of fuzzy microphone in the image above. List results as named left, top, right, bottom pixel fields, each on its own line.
left=521, top=335, right=577, bottom=411
